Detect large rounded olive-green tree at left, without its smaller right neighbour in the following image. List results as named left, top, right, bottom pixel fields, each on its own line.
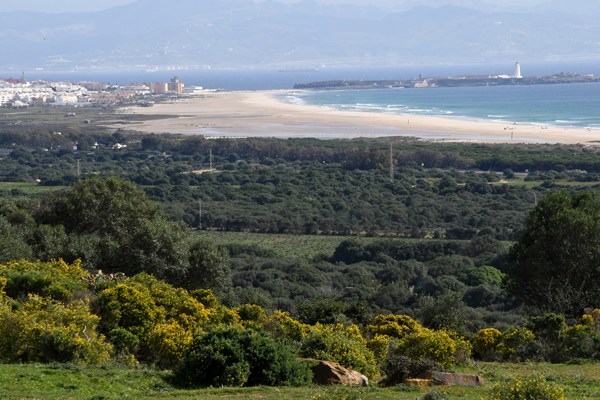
left=39, top=177, right=188, bottom=281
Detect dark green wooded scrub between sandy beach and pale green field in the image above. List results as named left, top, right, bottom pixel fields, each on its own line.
left=0, top=132, right=600, bottom=240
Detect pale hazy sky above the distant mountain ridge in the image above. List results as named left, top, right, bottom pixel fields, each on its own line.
left=0, top=0, right=544, bottom=12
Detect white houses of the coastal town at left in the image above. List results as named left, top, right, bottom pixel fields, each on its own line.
left=0, top=77, right=184, bottom=107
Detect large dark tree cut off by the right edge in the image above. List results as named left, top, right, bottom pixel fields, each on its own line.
left=508, top=191, right=600, bottom=316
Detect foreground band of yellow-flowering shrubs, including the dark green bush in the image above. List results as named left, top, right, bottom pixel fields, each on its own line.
left=0, top=261, right=600, bottom=387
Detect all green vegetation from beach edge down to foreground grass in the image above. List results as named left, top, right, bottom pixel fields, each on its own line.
left=0, top=122, right=600, bottom=399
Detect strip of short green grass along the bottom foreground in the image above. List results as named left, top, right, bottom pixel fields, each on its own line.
left=0, top=363, right=600, bottom=400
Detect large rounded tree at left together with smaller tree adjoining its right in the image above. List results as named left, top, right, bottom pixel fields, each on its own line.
left=36, top=177, right=231, bottom=292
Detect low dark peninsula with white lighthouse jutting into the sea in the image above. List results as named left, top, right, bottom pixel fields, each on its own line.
left=294, top=68, right=600, bottom=89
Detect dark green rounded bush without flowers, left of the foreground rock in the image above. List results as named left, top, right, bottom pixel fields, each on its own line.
left=173, top=327, right=312, bottom=387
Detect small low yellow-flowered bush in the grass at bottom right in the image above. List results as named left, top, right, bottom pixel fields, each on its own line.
left=488, top=376, right=565, bottom=400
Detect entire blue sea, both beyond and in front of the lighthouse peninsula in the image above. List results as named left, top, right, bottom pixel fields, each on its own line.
left=15, top=62, right=600, bottom=129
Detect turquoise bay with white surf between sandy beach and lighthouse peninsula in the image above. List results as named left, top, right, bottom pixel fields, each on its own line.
left=285, top=83, right=600, bottom=129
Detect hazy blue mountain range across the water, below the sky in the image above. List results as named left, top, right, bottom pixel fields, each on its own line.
left=0, top=0, right=600, bottom=71
